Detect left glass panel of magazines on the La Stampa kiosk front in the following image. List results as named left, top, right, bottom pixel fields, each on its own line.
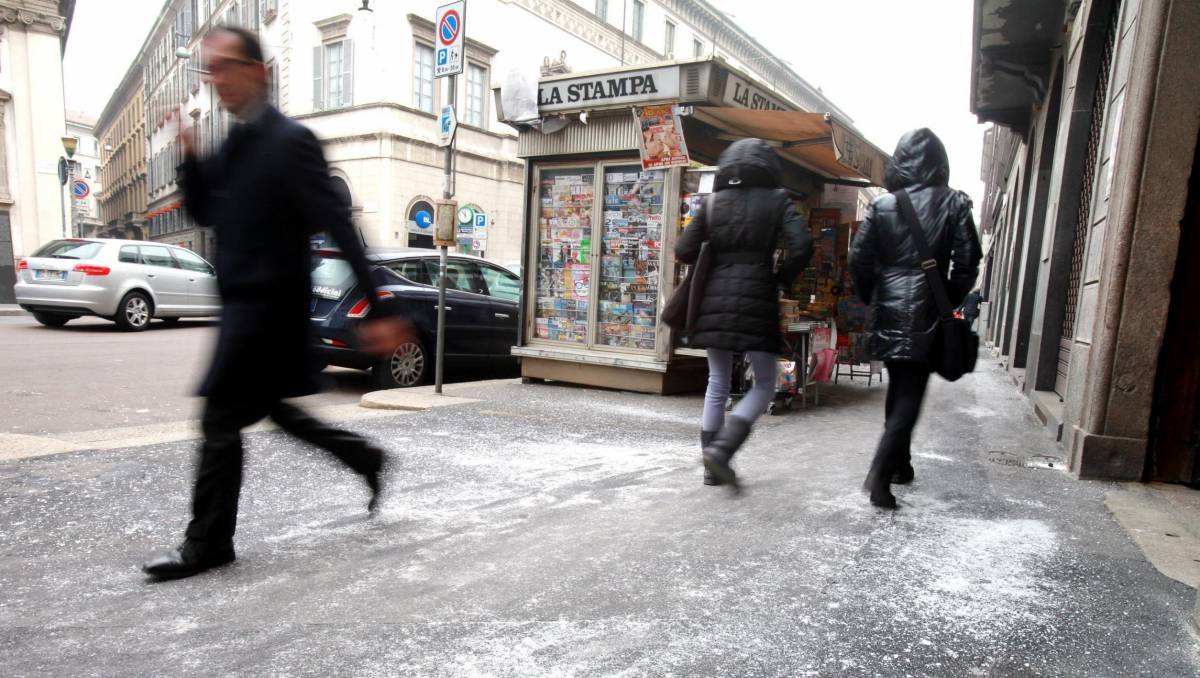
left=534, top=168, right=595, bottom=344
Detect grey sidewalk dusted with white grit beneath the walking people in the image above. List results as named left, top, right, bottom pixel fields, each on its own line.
left=0, top=361, right=1200, bottom=677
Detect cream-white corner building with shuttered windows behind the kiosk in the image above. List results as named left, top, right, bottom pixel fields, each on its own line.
left=110, top=0, right=864, bottom=263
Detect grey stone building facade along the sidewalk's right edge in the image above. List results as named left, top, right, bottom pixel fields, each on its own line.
left=972, top=0, right=1200, bottom=482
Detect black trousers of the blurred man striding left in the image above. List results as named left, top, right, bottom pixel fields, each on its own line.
left=187, top=398, right=383, bottom=544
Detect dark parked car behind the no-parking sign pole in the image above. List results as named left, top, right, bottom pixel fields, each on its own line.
left=312, top=250, right=521, bottom=388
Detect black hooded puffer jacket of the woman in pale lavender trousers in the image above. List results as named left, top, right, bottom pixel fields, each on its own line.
left=676, top=139, right=812, bottom=353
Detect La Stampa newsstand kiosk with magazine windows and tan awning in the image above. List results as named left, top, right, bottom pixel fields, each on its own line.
left=497, top=59, right=887, bottom=394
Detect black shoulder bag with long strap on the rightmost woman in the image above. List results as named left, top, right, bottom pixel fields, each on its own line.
left=894, top=191, right=979, bottom=382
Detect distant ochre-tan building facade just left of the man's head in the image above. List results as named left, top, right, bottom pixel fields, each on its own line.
left=96, top=61, right=148, bottom=240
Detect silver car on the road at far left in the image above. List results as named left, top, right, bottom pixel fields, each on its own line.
left=14, top=238, right=221, bottom=331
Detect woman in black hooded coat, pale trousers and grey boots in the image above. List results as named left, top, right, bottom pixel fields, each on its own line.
left=676, top=139, right=812, bottom=490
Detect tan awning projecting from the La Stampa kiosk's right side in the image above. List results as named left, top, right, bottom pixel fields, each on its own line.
left=695, top=107, right=888, bottom=186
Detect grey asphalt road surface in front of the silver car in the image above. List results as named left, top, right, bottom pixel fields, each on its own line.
left=0, top=316, right=384, bottom=436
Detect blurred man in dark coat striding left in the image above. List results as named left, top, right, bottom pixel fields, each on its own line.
left=143, top=28, right=410, bottom=578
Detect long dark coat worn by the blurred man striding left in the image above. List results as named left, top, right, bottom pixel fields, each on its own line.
left=179, top=107, right=376, bottom=402
